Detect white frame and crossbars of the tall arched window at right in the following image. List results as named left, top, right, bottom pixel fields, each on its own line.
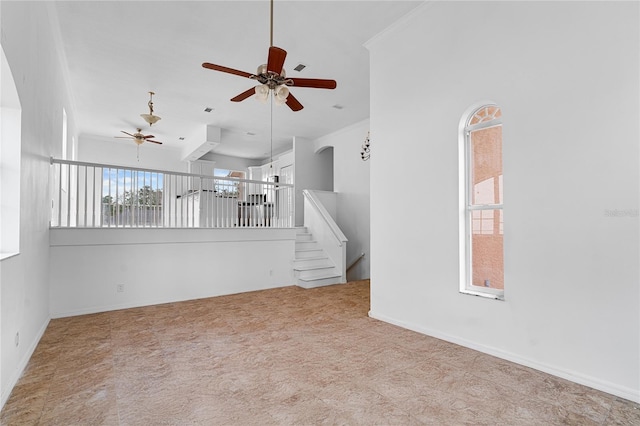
left=458, top=102, right=505, bottom=301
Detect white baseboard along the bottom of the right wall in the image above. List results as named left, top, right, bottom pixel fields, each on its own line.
left=369, top=311, right=640, bottom=403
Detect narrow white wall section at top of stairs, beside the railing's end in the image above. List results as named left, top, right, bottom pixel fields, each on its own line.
left=296, top=137, right=333, bottom=226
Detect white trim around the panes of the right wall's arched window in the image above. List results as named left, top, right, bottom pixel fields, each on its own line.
left=458, top=101, right=505, bottom=301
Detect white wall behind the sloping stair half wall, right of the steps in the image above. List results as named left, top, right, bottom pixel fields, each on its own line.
left=314, top=120, right=370, bottom=280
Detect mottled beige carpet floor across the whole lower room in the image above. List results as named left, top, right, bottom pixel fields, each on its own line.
left=0, top=281, right=640, bottom=426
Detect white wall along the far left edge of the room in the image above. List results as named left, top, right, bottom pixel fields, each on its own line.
left=0, top=2, right=75, bottom=403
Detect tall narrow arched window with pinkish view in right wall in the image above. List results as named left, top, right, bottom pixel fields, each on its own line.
left=460, top=104, right=504, bottom=299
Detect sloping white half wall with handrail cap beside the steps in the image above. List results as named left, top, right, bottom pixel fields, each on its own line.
left=302, top=189, right=348, bottom=283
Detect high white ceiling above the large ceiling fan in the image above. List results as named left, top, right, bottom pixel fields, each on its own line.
left=54, top=0, right=421, bottom=159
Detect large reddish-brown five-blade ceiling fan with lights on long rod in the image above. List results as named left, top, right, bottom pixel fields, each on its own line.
left=202, top=0, right=337, bottom=111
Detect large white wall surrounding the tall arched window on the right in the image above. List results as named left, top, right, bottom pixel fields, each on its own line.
left=369, top=2, right=640, bottom=401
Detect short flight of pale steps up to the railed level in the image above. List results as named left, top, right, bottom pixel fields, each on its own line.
left=293, top=227, right=341, bottom=288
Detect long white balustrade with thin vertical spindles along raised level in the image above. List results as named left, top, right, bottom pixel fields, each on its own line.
left=51, top=158, right=294, bottom=228
